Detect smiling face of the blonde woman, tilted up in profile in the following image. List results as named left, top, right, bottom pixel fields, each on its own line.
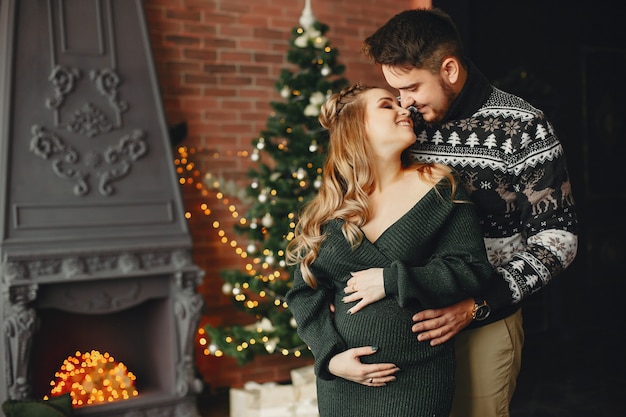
left=362, top=88, right=415, bottom=158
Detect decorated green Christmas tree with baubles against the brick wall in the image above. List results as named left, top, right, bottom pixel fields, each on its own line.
left=205, top=7, right=348, bottom=364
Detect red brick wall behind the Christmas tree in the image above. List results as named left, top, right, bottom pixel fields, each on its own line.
left=144, top=0, right=416, bottom=387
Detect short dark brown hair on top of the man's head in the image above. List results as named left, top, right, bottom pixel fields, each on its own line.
left=363, top=8, right=465, bottom=72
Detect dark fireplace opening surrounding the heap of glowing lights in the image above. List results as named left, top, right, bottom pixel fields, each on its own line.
left=30, top=279, right=176, bottom=402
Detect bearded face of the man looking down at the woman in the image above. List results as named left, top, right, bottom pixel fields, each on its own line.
left=382, top=65, right=456, bottom=123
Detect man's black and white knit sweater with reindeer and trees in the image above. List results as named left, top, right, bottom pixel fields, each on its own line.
left=412, top=64, right=578, bottom=325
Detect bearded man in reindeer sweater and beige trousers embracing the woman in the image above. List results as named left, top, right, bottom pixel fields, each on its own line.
left=356, top=9, right=578, bottom=417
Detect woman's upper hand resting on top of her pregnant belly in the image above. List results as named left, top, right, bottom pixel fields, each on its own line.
left=343, top=268, right=385, bottom=314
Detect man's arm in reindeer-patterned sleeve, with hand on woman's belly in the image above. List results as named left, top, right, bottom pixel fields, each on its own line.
left=413, top=117, right=578, bottom=345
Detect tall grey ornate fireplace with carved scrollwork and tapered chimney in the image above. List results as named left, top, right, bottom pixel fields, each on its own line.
left=0, top=0, right=203, bottom=417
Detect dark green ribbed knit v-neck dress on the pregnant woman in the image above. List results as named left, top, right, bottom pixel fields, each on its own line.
left=287, top=187, right=492, bottom=417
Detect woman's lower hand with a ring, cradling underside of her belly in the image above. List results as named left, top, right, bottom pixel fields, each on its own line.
left=328, top=346, right=399, bottom=387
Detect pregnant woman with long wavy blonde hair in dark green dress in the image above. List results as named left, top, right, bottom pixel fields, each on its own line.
left=287, top=85, right=491, bottom=417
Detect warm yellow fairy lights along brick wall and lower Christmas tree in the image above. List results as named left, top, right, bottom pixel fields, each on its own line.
left=174, top=146, right=310, bottom=357
